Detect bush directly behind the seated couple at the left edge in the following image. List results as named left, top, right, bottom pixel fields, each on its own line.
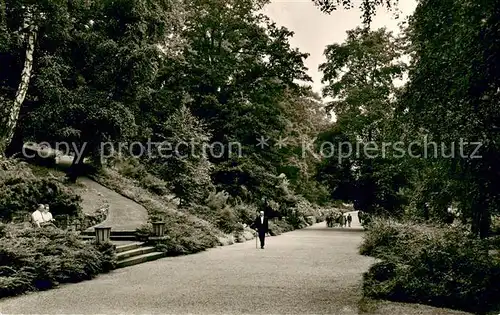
left=0, top=160, right=81, bottom=221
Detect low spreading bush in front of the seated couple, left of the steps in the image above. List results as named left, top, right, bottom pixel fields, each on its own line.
left=0, top=225, right=116, bottom=297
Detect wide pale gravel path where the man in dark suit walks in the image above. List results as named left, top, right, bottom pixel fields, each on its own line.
left=0, top=215, right=466, bottom=315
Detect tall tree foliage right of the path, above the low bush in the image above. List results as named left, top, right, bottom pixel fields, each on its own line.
left=312, top=1, right=500, bottom=237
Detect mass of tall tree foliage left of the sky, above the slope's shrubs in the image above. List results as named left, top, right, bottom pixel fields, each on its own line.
left=0, top=0, right=329, bottom=222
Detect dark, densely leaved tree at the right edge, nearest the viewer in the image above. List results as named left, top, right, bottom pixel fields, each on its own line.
left=400, top=0, right=500, bottom=237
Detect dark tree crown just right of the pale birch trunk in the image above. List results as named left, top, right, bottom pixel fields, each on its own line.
left=2, top=0, right=187, bottom=180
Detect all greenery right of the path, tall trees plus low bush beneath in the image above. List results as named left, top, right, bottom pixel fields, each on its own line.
left=314, top=0, right=500, bottom=311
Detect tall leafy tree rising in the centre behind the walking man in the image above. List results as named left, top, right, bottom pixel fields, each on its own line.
left=173, top=0, right=310, bottom=205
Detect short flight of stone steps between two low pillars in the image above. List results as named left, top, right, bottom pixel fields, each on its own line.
left=80, top=231, right=165, bottom=269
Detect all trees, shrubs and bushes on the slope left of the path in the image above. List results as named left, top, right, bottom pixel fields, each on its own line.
left=0, top=0, right=331, bottom=296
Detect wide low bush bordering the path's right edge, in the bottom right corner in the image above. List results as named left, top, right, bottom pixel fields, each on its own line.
left=360, top=220, right=500, bottom=313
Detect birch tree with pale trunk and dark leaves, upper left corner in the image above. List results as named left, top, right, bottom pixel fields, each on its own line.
left=0, top=0, right=68, bottom=154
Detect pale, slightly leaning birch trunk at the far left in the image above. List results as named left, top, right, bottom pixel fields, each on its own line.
left=0, top=9, right=37, bottom=155
